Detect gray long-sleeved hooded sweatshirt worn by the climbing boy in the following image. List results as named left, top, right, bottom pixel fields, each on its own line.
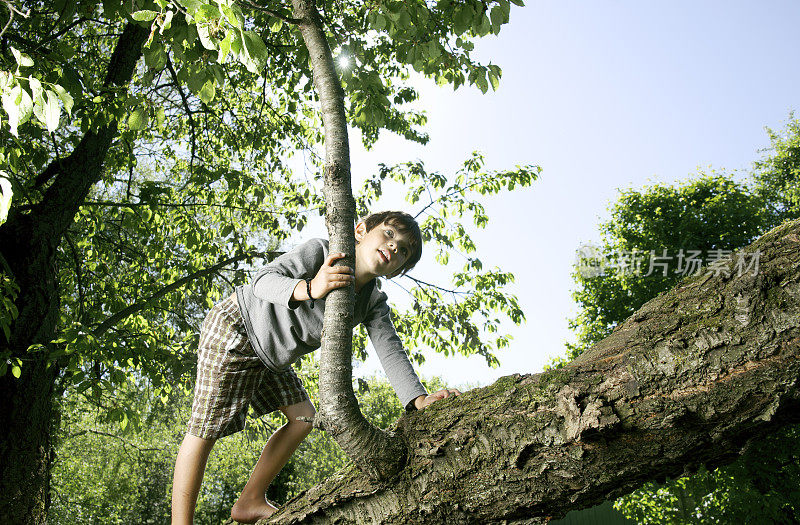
left=236, top=239, right=427, bottom=407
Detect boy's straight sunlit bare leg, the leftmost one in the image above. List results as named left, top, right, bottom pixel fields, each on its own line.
left=172, top=434, right=217, bottom=525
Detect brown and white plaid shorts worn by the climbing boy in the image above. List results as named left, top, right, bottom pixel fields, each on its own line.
left=187, top=294, right=308, bottom=439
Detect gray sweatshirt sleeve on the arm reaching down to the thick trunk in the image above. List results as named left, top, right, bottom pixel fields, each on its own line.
left=364, top=289, right=428, bottom=407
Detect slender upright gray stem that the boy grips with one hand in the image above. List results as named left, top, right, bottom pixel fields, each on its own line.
left=292, top=0, right=406, bottom=479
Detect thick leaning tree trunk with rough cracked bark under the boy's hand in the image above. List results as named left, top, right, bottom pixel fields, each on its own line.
left=264, top=216, right=800, bottom=524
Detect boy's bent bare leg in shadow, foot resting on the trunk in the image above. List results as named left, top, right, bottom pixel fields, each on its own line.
left=231, top=401, right=315, bottom=523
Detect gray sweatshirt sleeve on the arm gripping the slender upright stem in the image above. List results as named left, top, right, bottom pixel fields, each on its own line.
left=253, top=239, right=327, bottom=308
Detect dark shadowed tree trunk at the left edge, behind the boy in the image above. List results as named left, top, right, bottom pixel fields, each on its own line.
left=0, top=25, right=147, bottom=524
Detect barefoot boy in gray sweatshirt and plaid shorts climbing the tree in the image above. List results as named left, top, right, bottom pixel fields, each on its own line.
left=172, top=212, right=460, bottom=525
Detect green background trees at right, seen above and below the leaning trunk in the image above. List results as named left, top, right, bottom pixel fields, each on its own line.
left=568, top=116, right=800, bottom=523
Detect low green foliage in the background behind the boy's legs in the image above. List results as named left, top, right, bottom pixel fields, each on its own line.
left=49, top=366, right=442, bottom=525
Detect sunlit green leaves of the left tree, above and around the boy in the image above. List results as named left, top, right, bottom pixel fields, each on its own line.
left=0, top=0, right=535, bottom=421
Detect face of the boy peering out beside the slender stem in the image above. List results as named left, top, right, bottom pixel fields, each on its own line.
left=356, top=222, right=411, bottom=278
